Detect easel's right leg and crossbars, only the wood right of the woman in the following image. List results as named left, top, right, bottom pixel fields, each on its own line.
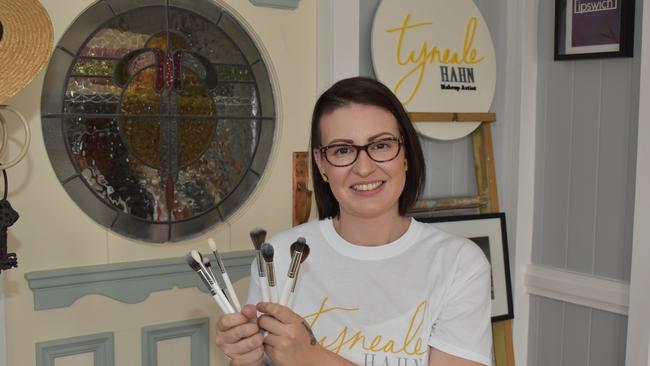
left=409, top=113, right=515, bottom=366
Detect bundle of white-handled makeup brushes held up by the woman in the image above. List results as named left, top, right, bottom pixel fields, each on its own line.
left=185, top=228, right=309, bottom=314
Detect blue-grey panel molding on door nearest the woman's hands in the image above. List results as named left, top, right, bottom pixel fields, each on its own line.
left=141, top=318, right=210, bottom=366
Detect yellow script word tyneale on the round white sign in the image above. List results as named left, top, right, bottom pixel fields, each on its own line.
left=386, top=14, right=485, bottom=105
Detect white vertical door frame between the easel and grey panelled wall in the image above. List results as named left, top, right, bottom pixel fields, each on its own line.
left=505, top=0, right=539, bottom=366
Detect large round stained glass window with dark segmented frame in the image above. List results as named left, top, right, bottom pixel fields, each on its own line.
left=41, top=0, right=276, bottom=242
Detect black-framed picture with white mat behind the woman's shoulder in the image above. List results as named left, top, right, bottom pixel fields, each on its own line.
left=417, top=212, right=514, bottom=322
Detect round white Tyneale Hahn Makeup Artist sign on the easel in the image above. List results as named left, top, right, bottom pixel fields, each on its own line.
left=372, top=0, right=496, bottom=139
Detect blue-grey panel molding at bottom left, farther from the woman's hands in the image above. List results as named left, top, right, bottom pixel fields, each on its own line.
left=36, top=332, right=115, bottom=366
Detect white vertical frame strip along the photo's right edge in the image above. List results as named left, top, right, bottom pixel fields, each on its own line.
left=625, top=3, right=650, bottom=366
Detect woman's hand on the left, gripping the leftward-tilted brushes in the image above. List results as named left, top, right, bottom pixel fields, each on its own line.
left=215, top=304, right=264, bottom=366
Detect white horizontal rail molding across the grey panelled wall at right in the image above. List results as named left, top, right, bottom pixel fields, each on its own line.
left=524, top=264, right=630, bottom=315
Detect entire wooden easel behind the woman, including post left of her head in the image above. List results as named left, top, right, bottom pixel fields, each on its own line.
left=292, top=113, right=515, bottom=366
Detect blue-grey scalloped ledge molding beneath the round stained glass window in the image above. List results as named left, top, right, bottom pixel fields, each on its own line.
left=25, top=250, right=255, bottom=310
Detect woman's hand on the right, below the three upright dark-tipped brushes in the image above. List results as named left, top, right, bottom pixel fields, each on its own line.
left=257, top=302, right=325, bottom=366
